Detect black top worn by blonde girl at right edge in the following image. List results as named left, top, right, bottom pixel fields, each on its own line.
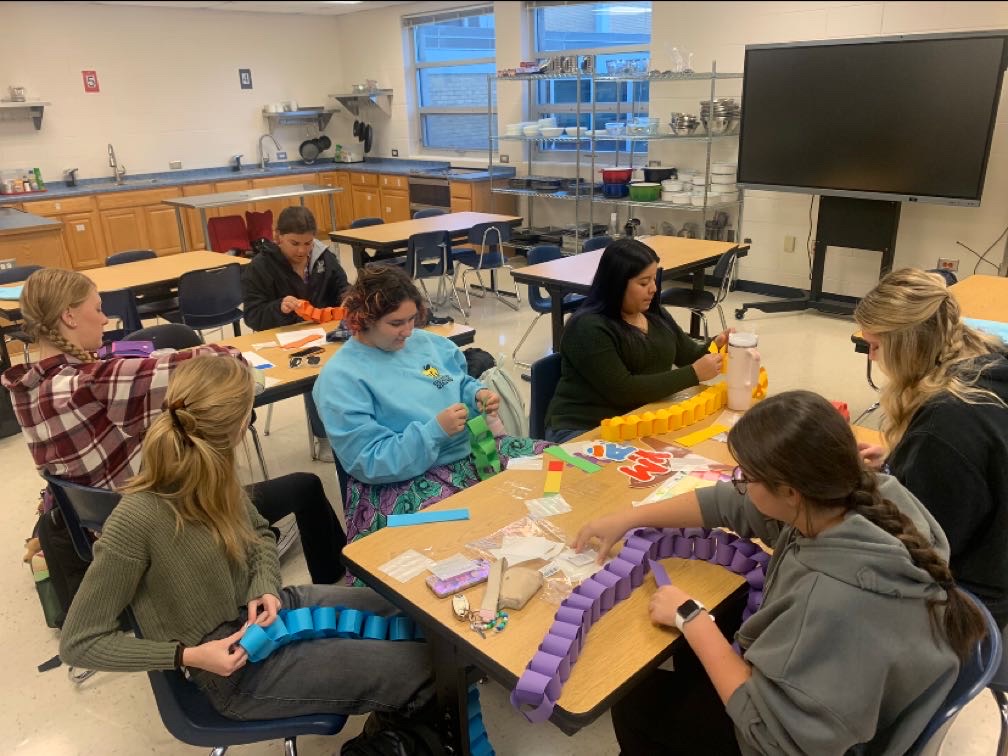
left=888, top=356, right=1008, bottom=627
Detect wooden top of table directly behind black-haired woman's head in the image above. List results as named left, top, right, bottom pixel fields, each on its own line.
left=511, top=236, right=737, bottom=291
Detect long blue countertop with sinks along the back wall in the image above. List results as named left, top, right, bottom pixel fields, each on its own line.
left=0, top=157, right=515, bottom=204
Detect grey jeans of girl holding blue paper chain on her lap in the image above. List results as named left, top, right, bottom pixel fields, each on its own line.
left=190, top=586, right=434, bottom=720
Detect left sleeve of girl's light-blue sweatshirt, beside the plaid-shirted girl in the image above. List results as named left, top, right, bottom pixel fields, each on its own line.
left=311, top=361, right=449, bottom=483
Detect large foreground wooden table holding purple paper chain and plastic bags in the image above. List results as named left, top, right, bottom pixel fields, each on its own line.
left=343, top=400, right=745, bottom=754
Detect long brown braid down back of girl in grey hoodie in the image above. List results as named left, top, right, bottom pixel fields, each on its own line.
left=851, top=470, right=986, bottom=661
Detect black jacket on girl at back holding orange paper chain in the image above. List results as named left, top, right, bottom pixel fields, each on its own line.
left=242, top=239, right=350, bottom=331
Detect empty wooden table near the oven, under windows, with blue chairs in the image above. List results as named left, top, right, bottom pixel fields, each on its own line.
left=329, top=213, right=521, bottom=269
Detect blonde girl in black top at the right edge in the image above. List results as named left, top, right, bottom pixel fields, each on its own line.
left=854, top=268, right=1008, bottom=627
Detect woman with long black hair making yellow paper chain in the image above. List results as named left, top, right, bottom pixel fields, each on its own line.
left=546, top=239, right=728, bottom=444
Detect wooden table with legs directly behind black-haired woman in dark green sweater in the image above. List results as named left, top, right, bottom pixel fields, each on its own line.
left=511, top=236, right=749, bottom=352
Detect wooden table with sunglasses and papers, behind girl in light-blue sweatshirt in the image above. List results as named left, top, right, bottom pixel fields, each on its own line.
left=216, top=322, right=476, bottom=407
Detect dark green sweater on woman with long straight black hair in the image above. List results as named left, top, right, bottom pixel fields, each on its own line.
left=546, top=313, right=707, bottom=430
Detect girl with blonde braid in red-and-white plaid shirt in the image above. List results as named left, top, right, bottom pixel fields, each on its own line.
left=2, top=268, right=346, bottom=608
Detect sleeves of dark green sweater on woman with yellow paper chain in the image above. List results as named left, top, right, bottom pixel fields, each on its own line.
left=561, top=316, right=704, bottom=406
